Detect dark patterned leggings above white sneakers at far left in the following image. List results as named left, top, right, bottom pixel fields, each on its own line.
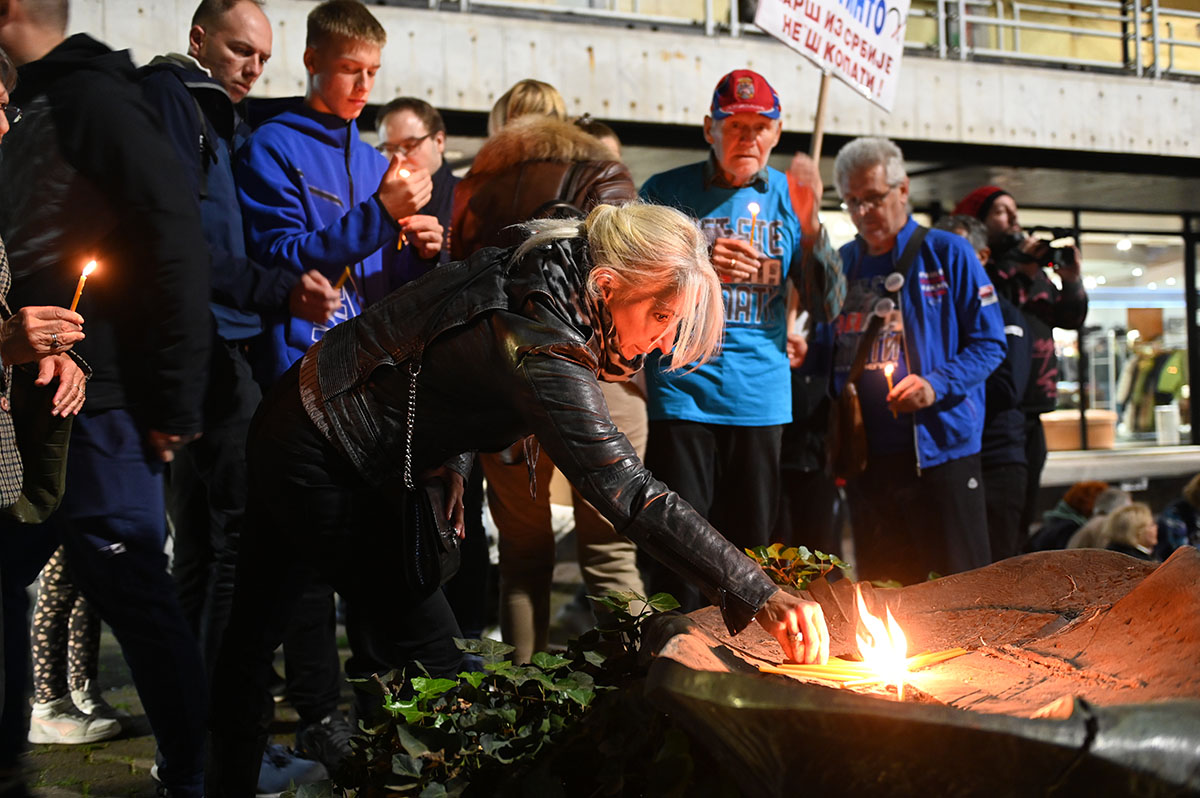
left=30, top=547, right=100, bottom=703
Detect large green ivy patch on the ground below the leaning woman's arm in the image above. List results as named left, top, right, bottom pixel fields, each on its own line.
left=328, top=593, right=679, bottom=798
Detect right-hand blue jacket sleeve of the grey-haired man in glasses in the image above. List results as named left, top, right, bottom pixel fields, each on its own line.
left=922, top=239, right=1008, bottom=400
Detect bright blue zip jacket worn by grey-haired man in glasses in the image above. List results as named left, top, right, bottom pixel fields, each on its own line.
left=834, top=217, right=1007, bottom=469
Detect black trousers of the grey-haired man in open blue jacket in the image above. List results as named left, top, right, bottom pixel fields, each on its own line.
left=847, top=454, right=991, bottom=584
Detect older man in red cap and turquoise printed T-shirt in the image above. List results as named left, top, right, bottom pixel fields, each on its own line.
left=641, top=70, right=845, bottom=610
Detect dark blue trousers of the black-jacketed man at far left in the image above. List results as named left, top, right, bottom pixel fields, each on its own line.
left=0, top=410, right=208, bottom=796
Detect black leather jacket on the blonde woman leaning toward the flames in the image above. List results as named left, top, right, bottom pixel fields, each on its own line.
left=300, top=240, right=776, bottom=634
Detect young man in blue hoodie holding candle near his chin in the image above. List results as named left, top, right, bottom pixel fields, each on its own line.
left=234, top=0, right=442, bottom=384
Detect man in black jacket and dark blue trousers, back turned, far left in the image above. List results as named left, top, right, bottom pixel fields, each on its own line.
left=0, top=0, right=211, bottom=797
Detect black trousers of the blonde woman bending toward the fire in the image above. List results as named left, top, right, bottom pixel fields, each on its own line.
left=206, top=370, right=462, bottom=798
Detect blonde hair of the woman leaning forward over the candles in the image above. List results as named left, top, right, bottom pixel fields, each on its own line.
left=514, top=203, right=725, bottom=371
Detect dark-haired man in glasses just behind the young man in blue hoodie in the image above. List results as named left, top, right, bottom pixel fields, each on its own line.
left=376, top=97, right=458, bottom=288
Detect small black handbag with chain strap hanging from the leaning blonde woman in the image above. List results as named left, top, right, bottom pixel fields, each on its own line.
left=401, top=354, right=462, bottom=595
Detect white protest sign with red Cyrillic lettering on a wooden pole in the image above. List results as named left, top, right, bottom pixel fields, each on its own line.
left=755, top=0, right=910, bottom=112
